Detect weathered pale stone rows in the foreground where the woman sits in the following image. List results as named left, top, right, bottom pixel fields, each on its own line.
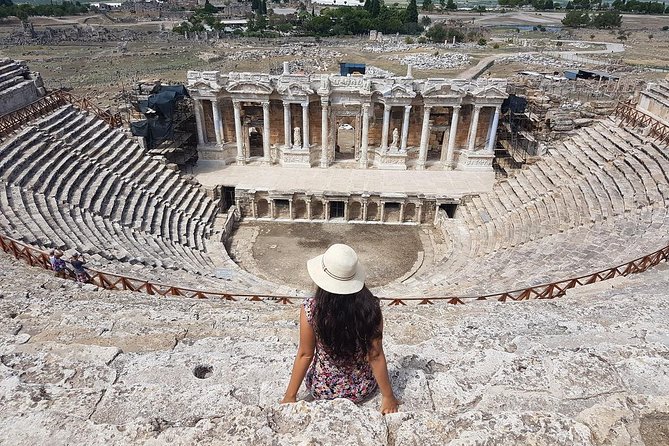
left=0, top=249, right=669, bottom=446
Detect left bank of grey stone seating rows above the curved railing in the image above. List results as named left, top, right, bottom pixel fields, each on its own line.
left=0, top=105, right=217, bottom=273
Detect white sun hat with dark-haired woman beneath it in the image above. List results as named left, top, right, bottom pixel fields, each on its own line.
left=307, top=244, right=365, bottom=294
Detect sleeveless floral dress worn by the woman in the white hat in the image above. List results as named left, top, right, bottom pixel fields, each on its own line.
left=304, top=297, right=377, bottom=403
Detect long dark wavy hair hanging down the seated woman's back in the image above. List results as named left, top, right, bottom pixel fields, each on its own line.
left=313, top=286, right=382, bottom=359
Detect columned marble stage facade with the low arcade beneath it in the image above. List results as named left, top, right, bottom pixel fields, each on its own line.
left=188, top=63, right=507, bottom=224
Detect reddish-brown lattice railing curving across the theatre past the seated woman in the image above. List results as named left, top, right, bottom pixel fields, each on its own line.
left=0, top=234, right=669, bottom=306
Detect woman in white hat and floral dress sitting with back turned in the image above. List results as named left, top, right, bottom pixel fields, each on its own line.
left=281, top=244, right=400, bottom=414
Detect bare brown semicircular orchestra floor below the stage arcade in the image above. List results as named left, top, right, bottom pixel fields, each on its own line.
left=233, top=222, right=423, bottom=290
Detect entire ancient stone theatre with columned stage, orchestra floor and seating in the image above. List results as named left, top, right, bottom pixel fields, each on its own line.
left=0, top=47, right=669, bottom=446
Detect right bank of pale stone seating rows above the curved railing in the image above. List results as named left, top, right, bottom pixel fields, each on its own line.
left=380, top=119, right=669, bottom=297
